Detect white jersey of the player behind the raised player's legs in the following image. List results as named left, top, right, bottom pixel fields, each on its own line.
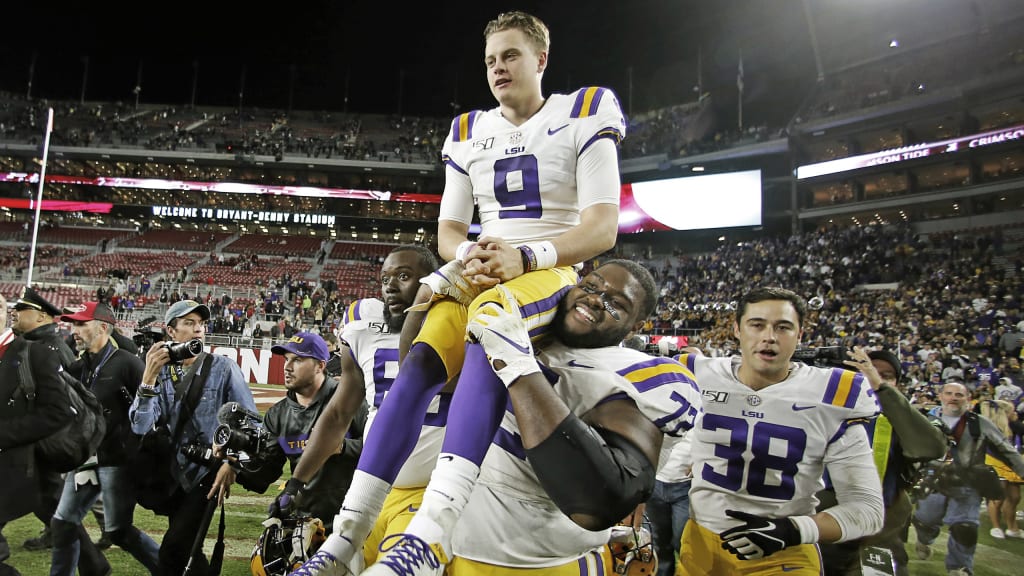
left=341, top=298, right=452, bottom=488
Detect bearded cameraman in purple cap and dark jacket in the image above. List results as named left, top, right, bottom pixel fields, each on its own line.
left=243, top=332, right=368, bottom=531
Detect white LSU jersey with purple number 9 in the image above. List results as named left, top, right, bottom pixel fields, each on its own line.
left=439, top=86, right=626, bottom=244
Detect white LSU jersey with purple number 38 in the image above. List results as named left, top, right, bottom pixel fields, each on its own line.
left=680, top=355, right=880, bottom=533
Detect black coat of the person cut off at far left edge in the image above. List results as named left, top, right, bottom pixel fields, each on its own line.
left=0, top=338, right=67, bottom=523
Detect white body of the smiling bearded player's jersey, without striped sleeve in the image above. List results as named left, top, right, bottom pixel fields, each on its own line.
left=452, top=367, right=632, bottom=569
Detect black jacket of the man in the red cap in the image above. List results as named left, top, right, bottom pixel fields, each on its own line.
left=68, top=341, right=145, bottom=466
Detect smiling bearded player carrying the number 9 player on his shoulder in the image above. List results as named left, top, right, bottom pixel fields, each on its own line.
left=356, top=260, right=700, bottom=576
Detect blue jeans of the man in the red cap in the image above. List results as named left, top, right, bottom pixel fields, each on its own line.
left=50, top=466, right=160, bottom=576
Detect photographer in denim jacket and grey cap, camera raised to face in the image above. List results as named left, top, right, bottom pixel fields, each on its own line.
left=129, top=300, right=257, bottom=574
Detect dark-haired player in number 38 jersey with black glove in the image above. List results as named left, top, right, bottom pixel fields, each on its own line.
left=676, top=288, right=883, bottom=576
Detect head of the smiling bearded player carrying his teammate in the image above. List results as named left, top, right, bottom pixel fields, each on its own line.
left=552, top=264, right=644, bottom=348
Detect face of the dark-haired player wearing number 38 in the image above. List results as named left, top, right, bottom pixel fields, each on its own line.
left=733, top=300, right=801, bottom=381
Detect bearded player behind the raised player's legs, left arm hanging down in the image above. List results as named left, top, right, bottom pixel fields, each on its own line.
left=270, top=245, right=440, bottom=561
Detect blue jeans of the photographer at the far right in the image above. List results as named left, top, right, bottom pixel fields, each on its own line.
left=913, top=486, right=981, bottom=574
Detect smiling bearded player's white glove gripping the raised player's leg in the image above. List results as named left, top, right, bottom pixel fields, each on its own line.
left=466, top=284, right=541, bottom=386
